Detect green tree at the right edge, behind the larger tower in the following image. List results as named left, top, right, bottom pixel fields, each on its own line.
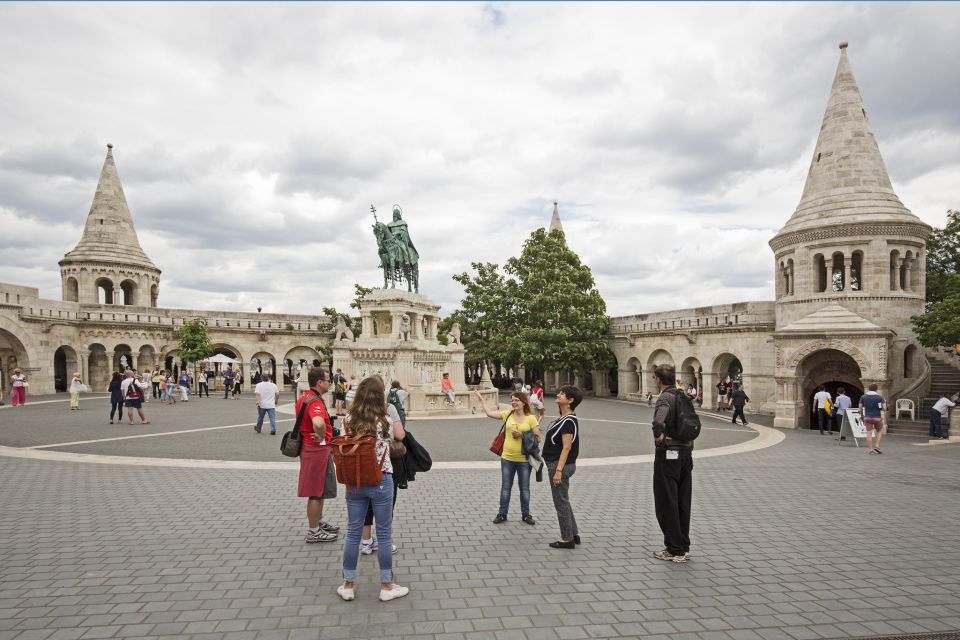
left=911, top=210, right=960, bottom=347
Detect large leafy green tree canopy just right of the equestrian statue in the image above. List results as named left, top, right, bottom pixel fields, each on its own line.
left=449, top=228, right=610, bottom=371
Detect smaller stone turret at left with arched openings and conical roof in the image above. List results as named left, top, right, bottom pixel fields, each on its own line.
left=60, top=144, right=160, bottom=307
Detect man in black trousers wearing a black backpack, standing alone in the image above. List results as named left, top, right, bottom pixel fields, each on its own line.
left=653, top=364, right=700, bottom=563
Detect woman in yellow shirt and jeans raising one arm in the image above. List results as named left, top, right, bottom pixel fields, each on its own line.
left=477, top=391, right=540, bottom=524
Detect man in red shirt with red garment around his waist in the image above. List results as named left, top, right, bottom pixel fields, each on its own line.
left=295, top=367, right=340, bottom=544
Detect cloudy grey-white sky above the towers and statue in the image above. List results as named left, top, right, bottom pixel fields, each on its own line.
left=0, top=3, right=960, bottom=315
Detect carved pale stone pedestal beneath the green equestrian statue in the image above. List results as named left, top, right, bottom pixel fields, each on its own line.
left=333, top=289, right=497, bottom=418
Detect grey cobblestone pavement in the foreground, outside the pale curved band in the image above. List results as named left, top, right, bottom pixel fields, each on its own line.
left=0, top=392, right=960, bottom=640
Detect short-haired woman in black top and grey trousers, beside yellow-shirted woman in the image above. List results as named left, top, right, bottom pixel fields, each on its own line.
left=542, top=385, right=583, bottom=549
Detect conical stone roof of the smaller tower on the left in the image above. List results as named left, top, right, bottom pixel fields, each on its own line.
left=60, top=144, right=160, bottom=273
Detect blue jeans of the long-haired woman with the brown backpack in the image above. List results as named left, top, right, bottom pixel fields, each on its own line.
left=343, top=472, right=394, bottom=582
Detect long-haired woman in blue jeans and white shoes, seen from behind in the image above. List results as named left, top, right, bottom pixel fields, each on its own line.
left=337, top=376, right=410, bottom=602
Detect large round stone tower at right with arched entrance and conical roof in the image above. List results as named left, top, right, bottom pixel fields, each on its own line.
left=770, top=42, right=930, bottom=427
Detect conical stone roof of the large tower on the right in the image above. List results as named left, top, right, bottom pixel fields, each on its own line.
left=777, top=42, right=926, bottom=237
